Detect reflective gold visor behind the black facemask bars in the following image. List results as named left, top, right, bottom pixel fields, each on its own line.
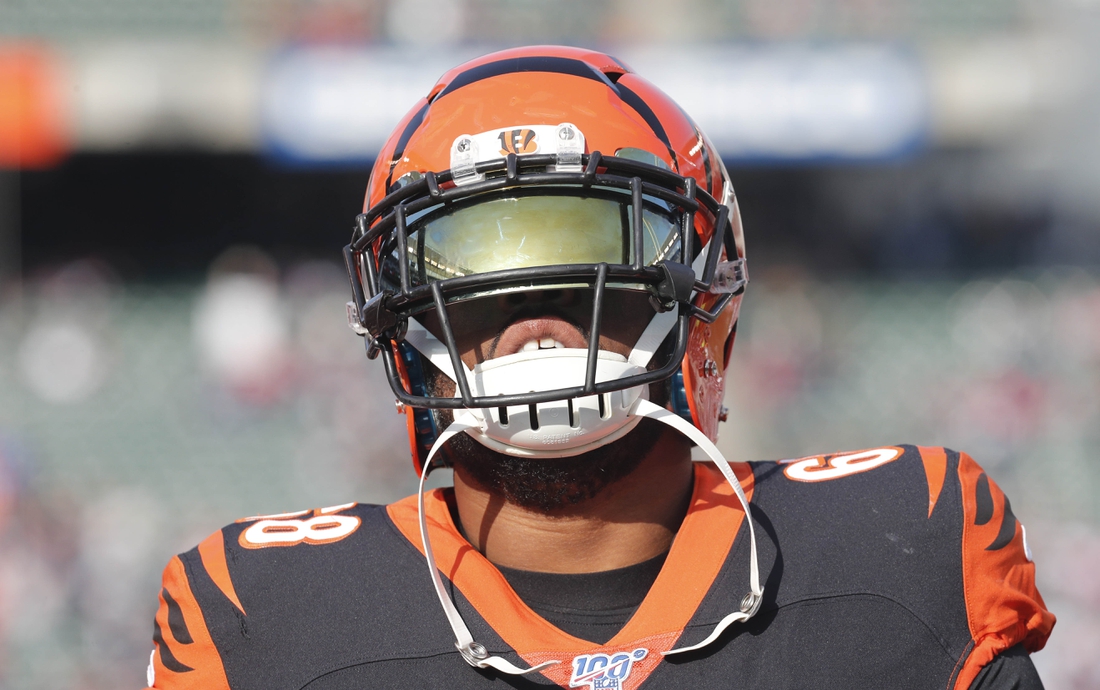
left=393, top=195, right=680, bottom=285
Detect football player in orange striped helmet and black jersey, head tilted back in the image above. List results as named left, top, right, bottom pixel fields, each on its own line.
left=141, top=46, right=1054, bottom=690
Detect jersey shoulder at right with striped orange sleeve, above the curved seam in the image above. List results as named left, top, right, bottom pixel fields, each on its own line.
left=751, top=445, right=1054, bottom=687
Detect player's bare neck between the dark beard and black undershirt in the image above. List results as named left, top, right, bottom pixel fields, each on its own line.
left=454, top=434, right=693, bottom=572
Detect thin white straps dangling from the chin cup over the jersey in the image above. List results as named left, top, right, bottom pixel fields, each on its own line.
left=417, top=398, right=763, bottom=676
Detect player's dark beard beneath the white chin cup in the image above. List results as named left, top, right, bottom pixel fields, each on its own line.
left=441, top=418, right=663, bottom=514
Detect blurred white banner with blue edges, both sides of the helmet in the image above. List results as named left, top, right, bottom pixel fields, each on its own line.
left=261, top=45, right=928, bottom=163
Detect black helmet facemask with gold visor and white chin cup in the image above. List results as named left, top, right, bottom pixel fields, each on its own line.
left=345, top=152, right=745, bottom=466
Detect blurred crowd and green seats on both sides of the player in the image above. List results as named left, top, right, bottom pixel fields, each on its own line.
left=0, top=255, right=1100, bottom=690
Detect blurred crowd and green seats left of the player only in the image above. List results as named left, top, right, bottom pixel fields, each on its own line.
left=0, top=254, right=415, bottom=690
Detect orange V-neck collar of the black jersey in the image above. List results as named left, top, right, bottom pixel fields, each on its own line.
left=386, top=462, right=754, bottom=688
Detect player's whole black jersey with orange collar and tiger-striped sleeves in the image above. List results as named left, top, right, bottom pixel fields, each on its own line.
left=150, top=446, right=1054, bottom=690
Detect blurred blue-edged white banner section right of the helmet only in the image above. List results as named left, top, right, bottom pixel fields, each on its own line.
left=627, top=44, right=930, bottom=163
